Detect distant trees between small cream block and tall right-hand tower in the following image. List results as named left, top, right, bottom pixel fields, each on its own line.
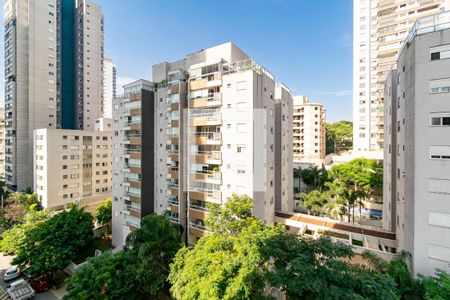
left=325, top=121, right=353, bottom=154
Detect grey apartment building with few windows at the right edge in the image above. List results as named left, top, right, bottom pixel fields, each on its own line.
left=383, top=12, right=450, bottom=275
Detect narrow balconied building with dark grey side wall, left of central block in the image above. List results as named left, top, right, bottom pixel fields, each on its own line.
left=112, top=79, right=157, bottom=246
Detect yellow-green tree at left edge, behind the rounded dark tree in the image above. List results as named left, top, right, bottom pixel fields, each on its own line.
left=0, top=210, right=54, bottom=254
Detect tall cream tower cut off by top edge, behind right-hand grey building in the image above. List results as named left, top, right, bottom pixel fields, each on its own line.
left=353, top=0, right=450, bottom=159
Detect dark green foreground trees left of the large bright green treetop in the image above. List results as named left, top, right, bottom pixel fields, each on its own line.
left=64, top=216, right=182, bottom=300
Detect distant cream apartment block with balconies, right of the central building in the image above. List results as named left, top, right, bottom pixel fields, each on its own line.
left=293, top=96, right=326, bottom=166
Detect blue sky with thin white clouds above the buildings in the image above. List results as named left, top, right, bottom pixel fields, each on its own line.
left=0, top=0, right=353, bottom=122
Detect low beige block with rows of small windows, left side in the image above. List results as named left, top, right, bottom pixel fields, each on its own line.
left=34, top=128, right=112, bottom=210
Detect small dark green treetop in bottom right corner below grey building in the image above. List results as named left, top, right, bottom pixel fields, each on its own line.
left=418, top=269, right=450, bottom=300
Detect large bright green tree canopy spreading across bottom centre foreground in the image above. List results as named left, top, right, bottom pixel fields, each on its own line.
left=169, top=197, right=397, bottom=299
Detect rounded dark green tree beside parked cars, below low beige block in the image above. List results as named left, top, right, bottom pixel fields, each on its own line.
left=13, top=205, right=93, bottom=276
